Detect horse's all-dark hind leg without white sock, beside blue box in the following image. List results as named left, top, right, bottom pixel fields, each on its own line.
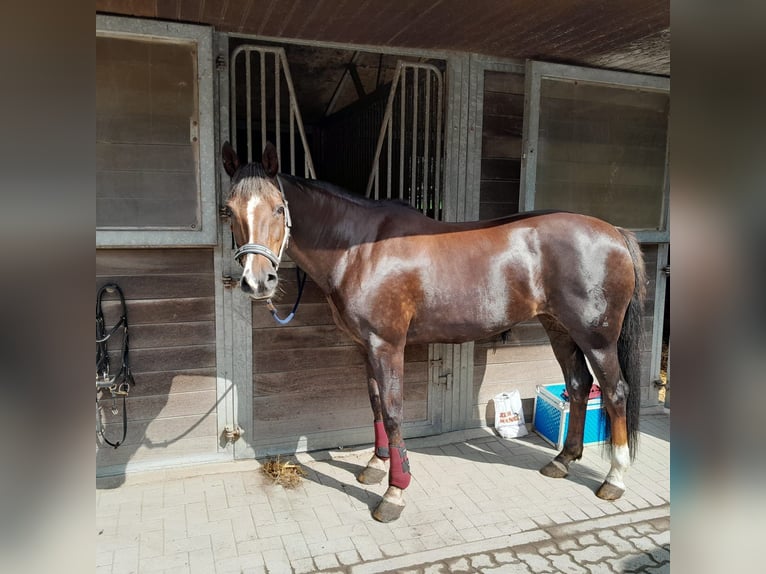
left=539, top=316, right=593, bottom=478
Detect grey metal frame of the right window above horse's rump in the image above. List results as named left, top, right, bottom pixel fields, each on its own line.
left=519, top=60, right=670, bottom=243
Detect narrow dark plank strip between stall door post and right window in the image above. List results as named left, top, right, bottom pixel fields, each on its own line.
left=479, top=71, right=524, bottom=219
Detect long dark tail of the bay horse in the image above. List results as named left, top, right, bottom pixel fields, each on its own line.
left=617, top=227, right=646, bottom=460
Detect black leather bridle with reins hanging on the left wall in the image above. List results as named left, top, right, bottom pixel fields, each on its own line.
left=96, top=283, right=136, bottom=448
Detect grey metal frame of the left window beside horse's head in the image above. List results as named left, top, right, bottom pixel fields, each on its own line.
left=96, top=14, right=218, bottom=248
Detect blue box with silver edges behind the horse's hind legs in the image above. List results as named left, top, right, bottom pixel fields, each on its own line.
left=532, top=384, right=609, bottom=450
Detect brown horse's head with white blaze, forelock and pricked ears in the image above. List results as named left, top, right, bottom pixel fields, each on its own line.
left=221, top=142, right=290, bottom=299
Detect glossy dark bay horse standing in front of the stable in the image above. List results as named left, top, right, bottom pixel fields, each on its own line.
left=221, top=142, right=646, bottom=522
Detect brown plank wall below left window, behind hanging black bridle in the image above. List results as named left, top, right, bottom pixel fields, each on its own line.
left=96, top=249, right=217, bottom=474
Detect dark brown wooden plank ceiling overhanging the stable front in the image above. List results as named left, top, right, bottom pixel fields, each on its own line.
left=96, top=0, right=670, bottom=76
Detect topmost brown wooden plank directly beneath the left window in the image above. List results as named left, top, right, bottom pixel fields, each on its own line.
left=96, top=248, right=213, bottom=277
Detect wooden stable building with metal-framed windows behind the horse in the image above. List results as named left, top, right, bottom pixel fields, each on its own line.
left=96, top=0, right=670, bottom=475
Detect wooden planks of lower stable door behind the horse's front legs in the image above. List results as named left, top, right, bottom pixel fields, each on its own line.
left=253, top=269, right=428, bottom=449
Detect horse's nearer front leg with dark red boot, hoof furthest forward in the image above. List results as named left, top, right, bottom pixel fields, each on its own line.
left=368, top=336, right=412, bottom=522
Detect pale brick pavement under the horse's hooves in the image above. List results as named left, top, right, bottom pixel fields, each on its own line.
left=96, top=415, right=670, bottom=574
